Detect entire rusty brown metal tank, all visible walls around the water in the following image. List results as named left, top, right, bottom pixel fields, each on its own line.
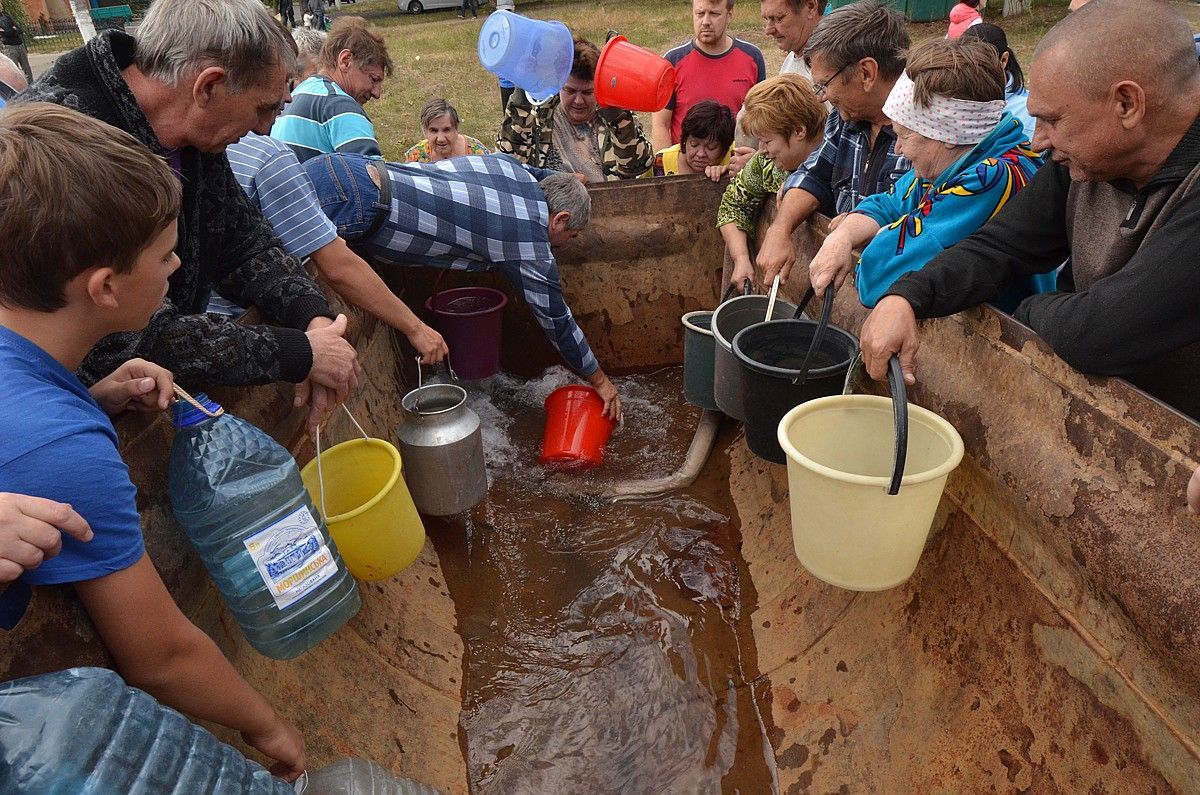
left=0, top=177, right=1200, bottom=793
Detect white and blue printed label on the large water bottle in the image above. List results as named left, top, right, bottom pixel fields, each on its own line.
left=244, top=507, right=337, bottom=610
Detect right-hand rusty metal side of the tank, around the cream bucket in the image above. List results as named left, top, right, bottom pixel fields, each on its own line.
left=731, top=210, right=1200, bottom=793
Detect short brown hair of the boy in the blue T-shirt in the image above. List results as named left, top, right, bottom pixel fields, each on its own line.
left=0, top=102, right=180, bottom=312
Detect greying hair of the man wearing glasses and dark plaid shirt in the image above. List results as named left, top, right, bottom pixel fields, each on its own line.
left=804, top=0, right=911, bottom=80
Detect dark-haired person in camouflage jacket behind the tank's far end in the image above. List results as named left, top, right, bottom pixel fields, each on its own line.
left=496, top=36, right=654, bottom=183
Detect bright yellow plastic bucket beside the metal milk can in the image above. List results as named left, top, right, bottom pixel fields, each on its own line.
left=300, top=438, right=425, bottom=580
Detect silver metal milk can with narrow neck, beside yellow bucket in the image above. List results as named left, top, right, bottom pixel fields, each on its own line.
left=396, top=384, right=487, bottom=516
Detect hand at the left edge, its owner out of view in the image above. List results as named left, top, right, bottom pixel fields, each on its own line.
left=0, top=494, right=91, bottom=582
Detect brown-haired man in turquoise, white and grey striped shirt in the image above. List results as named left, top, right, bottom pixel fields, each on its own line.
left=271, top=17, right=392, bottom=162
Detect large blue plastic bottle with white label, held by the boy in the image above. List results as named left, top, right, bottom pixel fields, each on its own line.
left=168, top=395, right=362, bottom=659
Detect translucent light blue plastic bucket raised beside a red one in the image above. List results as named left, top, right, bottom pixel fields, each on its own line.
left=478, top=11, right=575, bottom=102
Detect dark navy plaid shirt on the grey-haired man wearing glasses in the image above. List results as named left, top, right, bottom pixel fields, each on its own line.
left=782, top=110, right=912, bottom=217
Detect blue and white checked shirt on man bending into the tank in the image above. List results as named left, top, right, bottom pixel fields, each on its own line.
left=364, top=155, right=600, bottom=376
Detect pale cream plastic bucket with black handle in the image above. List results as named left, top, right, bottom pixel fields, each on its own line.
left=779, top=364, right=962, bottom=591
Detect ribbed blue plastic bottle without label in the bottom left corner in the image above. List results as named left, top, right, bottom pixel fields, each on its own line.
left=0, top=668, right=295, bottom=795
